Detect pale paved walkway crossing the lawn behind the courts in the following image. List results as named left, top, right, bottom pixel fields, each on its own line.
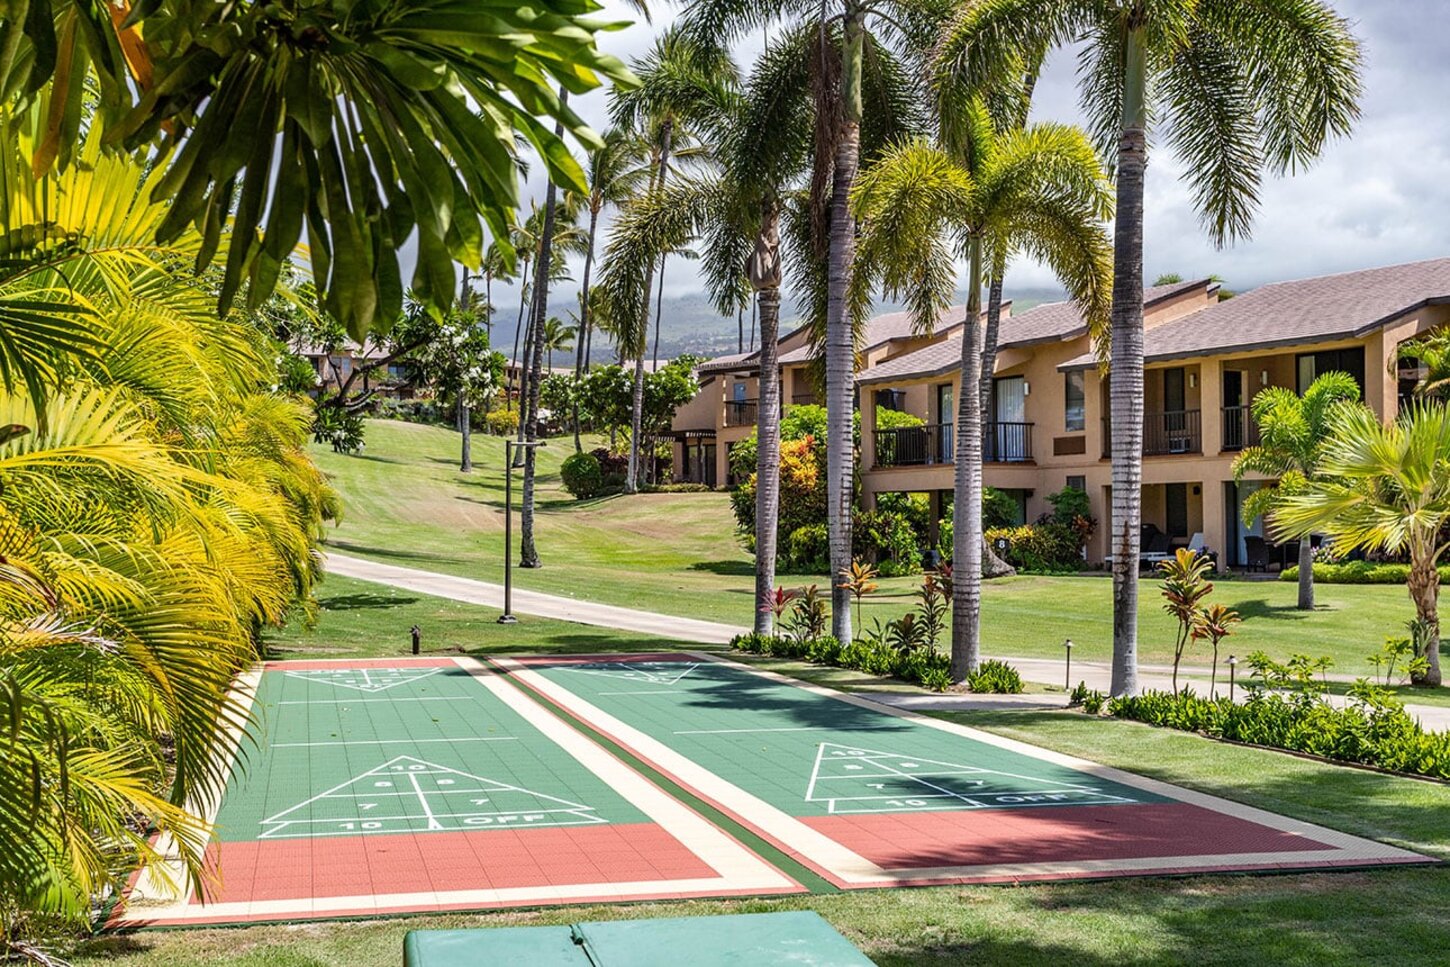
left=328, top=554, right=1450, bottom=731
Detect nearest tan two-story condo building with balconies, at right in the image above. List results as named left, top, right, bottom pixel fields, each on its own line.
left=858, top=258, right=1450, bottom=565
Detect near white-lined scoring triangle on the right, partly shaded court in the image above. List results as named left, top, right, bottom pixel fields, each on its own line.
left=806, top=742, right=1137, bottom=813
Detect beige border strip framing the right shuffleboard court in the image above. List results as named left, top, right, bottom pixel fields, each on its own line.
left=493, top=651, right=1433, bottom=887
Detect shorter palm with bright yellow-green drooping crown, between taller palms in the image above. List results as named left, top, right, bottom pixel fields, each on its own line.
left=854, top=100, right=1112, bottom=681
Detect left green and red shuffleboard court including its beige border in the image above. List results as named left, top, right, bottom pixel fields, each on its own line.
left=112, top=658, right=802, bottom=926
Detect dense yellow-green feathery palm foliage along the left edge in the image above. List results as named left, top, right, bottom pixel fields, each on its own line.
left=0, top=130, right=336, bottom=939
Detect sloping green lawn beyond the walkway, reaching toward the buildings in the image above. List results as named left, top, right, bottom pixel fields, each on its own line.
left=315, top=420, right=1432, bottom=674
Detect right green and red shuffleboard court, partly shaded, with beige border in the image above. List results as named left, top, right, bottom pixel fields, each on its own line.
left=496, top=654, right=1425, bottom=887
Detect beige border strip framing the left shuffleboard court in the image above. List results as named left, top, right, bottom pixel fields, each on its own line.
left=110, top=657, right=803, bottom=928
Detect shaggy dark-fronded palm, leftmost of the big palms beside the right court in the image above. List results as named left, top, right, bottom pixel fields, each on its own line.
left=605, top=32, right=812, bottom=634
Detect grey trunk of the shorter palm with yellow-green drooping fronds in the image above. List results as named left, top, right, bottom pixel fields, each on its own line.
left=951, top=236, right=983, bottom=681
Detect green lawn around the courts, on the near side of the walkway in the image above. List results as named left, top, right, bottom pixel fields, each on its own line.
left=68, top=580, right=1450, bottom=967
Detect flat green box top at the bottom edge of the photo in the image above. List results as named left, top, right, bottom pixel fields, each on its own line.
left=403, top=912, right=873, bottom=967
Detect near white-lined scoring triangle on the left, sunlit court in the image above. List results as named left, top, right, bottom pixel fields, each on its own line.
left=257, top=755, right=606, bottom=839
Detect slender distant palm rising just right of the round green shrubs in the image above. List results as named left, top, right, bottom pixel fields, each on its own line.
left=610, top=28, right=738, bottom=493
